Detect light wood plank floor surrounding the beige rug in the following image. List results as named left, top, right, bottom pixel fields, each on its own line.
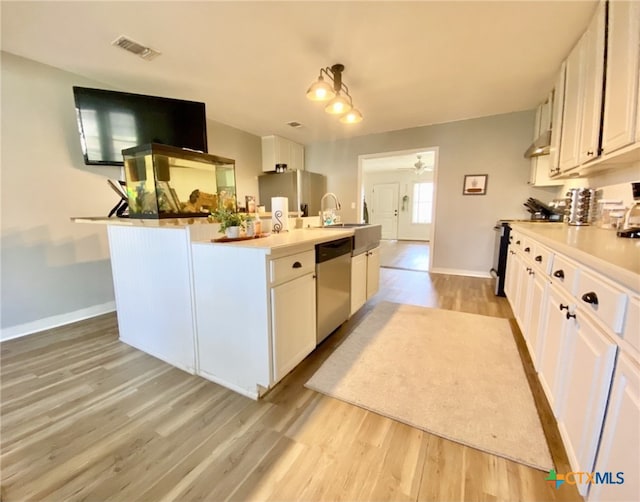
left=0, top=269, right=581, bottom=502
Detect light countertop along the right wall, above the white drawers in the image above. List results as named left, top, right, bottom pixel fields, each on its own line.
left=511, top=222, right=640, bottom=293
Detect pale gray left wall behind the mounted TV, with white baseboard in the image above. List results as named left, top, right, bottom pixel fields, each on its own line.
left=0, top=52, right=261, bottom=339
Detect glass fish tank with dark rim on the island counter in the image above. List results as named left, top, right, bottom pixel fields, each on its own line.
left=122, top=143, right=237, bottom=219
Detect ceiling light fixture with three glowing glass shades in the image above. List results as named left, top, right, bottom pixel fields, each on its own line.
left=307, top=63, right=362, bottom=124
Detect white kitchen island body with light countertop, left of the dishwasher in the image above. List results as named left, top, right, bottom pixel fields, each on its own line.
left=73, top=218, right=376, bottom=399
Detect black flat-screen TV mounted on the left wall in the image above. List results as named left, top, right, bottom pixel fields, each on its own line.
left=73, top=86, right=207, bottom=166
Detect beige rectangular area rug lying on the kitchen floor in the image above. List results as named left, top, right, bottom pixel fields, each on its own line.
left=306, top=302, right=553, bottom=471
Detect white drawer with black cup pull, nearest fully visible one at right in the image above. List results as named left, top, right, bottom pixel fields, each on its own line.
left=576, top=270, right=627, bottom=333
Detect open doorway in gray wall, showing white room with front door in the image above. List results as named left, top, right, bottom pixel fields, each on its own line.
left=358, top=147, right=438, bottom=270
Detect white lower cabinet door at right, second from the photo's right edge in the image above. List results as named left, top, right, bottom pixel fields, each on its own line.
left=558, top=308, right=617, bottom=495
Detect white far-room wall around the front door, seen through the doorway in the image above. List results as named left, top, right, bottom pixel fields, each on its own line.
left=362, top=170, right=433, bottom=241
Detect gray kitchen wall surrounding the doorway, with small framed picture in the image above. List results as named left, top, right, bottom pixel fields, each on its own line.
left=305, top=111, right=558, bottom=276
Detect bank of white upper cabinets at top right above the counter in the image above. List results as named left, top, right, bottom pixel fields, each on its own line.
left=550, top=0, right=640, bottom=179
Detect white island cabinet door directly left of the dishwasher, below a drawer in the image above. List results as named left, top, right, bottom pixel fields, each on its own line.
left=271, top=273, right=316, bottom=383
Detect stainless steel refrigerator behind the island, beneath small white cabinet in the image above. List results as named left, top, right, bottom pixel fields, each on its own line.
left=258, top=171, right=327, bottom=216
